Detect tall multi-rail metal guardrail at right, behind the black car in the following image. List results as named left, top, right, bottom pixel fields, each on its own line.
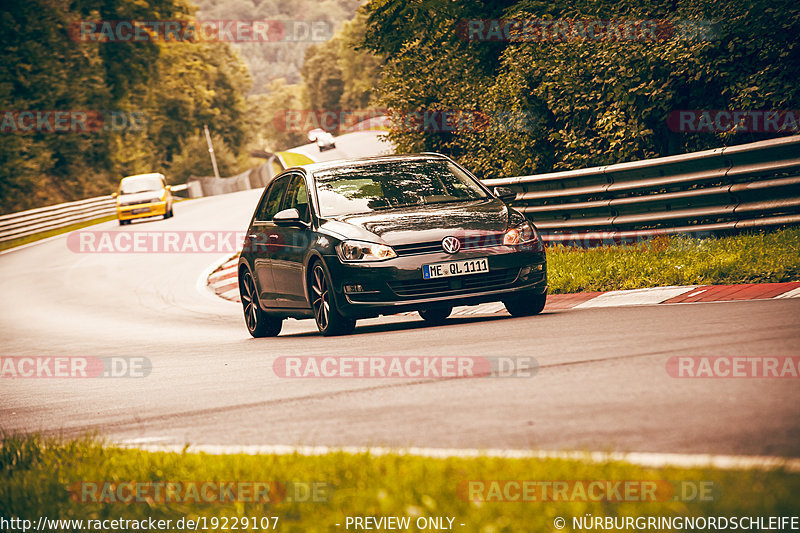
left=484, top=135, right=800, bottom=245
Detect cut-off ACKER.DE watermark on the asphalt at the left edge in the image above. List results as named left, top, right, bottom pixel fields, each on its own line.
left=0, top=356, right=153, bottom=379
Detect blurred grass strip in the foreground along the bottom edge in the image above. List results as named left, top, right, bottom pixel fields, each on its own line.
left=0, top=436, right=800, bottom=533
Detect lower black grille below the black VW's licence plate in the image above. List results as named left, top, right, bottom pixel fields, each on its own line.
left=389, top=268, right=519, bottom=298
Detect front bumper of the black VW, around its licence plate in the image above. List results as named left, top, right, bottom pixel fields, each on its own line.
left=325, top=246, right=547, bottom=318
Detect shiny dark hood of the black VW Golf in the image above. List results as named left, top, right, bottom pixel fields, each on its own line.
left=323, top=198, right=508, bottom=245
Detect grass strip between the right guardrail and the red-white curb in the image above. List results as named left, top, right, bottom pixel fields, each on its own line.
left=547, top=228, right=800, bottom=294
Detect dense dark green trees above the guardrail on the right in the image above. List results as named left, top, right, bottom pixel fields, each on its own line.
left=363, top=0, right=800, bottom=178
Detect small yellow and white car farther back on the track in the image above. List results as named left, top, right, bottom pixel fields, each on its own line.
left=112, top=173, right=172, bottom=226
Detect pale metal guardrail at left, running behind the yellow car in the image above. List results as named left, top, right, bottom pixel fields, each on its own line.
left=0, top=185, right=186, bottom=242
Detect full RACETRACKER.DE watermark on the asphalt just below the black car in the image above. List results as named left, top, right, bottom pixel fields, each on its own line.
left=272, top=355, right=539, bottom=379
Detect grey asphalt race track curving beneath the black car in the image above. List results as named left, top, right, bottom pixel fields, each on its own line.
left=0, top=186, right=800, bottom=457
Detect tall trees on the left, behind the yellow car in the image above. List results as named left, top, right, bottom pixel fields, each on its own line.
left=0, top=0, right=251, bottom=213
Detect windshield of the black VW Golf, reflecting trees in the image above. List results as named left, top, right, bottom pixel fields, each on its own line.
left=314, top=159, right=487, bottom=217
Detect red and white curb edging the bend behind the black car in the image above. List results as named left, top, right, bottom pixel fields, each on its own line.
left=208, top=255, right=800, bottom=316
